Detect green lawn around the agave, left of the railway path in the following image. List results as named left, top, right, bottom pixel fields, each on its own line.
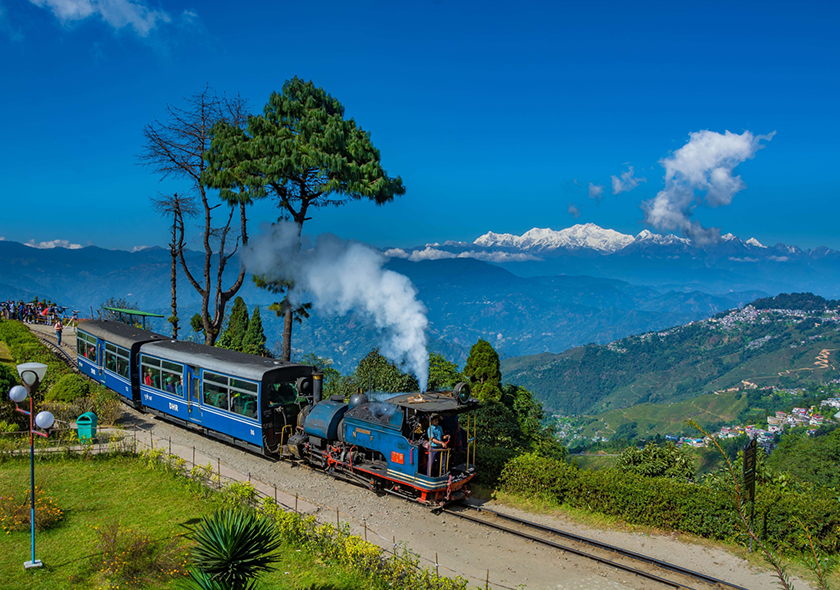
left=0, top=456, right=384, bottom=590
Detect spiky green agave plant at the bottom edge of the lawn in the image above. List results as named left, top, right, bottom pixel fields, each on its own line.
left=188, top=508, right=282, bottom=590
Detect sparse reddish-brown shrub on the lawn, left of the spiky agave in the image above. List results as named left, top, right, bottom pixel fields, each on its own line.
left=96, top=522, right=188, bottom=588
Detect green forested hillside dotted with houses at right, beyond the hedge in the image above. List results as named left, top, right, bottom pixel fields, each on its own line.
left=502, top=293, right=840, bottom=415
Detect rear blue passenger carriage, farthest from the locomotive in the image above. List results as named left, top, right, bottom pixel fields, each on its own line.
left=76, top=320, right=166, bottom=409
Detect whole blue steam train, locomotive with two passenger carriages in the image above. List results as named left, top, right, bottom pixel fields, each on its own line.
left=76, top=321, right=478, bottom=505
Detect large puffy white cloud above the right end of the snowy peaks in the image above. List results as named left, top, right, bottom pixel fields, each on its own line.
left=642, top=130, right=776, bottom=244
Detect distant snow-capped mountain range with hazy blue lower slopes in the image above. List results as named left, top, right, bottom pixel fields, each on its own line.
left=386, top=223, right=840, bottom=297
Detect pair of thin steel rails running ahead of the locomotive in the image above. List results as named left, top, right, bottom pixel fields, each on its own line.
left=441, top=503, right=748, bottom=590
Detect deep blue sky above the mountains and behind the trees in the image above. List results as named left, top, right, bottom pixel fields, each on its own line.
left=0, top=0, right=840, bottom=249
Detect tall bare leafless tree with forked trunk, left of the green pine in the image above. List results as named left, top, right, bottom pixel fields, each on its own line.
left=139, top=87, right=251, bottom=346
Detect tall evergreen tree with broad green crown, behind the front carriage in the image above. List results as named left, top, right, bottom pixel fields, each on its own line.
left=208, top=77, right=405, bottom=361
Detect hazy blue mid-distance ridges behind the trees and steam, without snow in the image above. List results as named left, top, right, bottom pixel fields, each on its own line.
left=0, top=241, right=767, bottom=370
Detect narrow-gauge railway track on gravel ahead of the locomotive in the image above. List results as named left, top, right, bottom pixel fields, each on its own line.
left=441, top=503, right=747, bottom=590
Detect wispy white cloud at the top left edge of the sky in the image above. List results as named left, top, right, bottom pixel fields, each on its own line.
left=29, top=0, right=172, bottom=37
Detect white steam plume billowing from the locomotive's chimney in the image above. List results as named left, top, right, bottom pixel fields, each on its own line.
left=242, top=222, right=429, bottom=391
